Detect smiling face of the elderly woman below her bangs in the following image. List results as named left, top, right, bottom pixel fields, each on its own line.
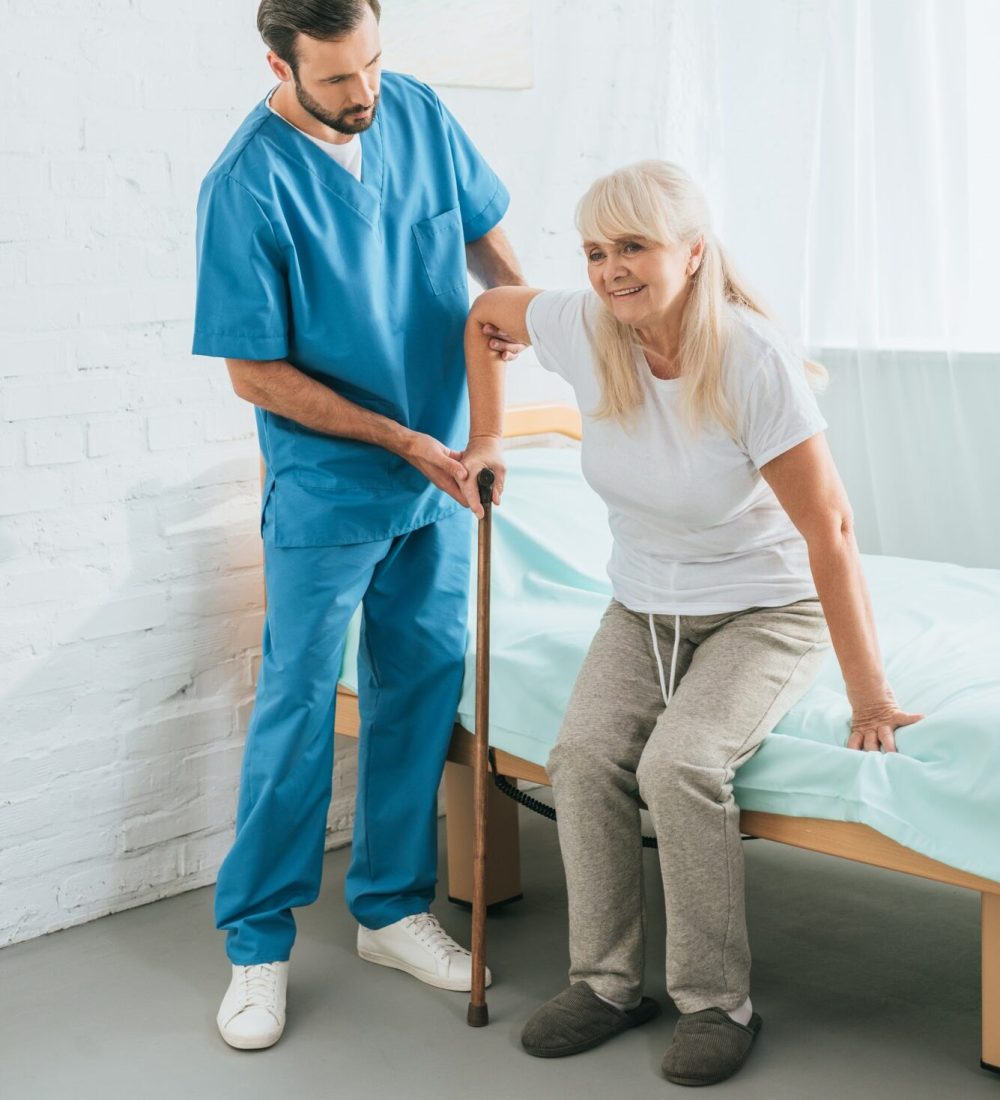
left=583, top=237, right=696, bottom=329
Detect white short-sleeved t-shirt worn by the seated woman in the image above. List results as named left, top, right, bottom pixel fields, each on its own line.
left=527, top=290, right=826, bottom=615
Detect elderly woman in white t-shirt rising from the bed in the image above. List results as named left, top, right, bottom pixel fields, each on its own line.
left=462, top=161, right=921, bottom=1085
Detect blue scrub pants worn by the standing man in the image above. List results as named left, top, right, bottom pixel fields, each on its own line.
left=216, top=509, right=472, bottom=966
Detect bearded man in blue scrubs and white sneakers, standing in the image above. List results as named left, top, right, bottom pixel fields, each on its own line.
left=194, top=0, right=523, bottom=1049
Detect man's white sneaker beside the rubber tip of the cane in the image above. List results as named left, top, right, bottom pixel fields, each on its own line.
left=358, top=913, right=493, bottom=992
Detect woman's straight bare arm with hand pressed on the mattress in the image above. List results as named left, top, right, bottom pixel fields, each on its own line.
left=760, top=433, right=923, bottom=752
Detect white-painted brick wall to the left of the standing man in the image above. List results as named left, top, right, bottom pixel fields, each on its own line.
left=0, top=0, right=365, bottom=946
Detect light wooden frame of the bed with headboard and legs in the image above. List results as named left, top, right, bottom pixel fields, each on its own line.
left=283, top=405, right=1000, bottom=1073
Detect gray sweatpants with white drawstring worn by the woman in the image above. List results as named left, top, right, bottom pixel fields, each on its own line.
left=548, top=600, right=829, bottom=1012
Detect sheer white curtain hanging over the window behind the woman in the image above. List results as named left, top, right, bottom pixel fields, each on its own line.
left=715, top=0, right=1000, bottom=567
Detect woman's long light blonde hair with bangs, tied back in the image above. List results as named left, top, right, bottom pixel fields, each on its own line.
left=576, top=161, right=827, bottom=438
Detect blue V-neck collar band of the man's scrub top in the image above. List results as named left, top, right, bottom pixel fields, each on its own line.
left=260, top=92, right=385, bottom=227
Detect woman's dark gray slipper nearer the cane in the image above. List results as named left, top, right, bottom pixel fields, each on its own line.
left=520, top=981, right=660, bottom=1058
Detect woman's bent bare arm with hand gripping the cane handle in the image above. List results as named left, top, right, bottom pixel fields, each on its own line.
left=460, top=286, right=541, bottom=518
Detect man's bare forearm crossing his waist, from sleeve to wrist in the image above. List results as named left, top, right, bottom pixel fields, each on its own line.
left=226, top=359, right=414, bottom=455
